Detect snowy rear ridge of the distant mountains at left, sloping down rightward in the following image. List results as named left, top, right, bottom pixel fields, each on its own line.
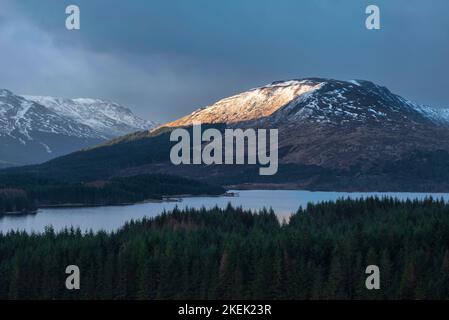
left=23, top=96, right=156, bottom=138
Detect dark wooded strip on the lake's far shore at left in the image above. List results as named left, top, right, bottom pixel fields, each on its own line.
left=0, top=174, right=225, bottom=214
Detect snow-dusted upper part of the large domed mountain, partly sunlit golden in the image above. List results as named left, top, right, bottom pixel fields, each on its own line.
left=164, top=78, right=449, bottom=127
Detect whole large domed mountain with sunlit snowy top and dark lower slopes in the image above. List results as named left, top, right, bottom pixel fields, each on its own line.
left=8, top=78, right=449, bottom=191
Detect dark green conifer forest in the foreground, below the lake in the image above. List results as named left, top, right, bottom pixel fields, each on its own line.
left=0, top=198, right=449, bottom=300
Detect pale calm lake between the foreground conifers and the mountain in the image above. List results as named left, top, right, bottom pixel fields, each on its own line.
left=0, top=190, right=449, bottom=233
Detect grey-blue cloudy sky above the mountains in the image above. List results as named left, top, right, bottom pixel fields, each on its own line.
left=0, top=0, right=449, bottom=122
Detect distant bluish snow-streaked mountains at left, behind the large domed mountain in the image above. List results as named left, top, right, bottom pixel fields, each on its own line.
left=0, top=89, right=155, bottom=167
